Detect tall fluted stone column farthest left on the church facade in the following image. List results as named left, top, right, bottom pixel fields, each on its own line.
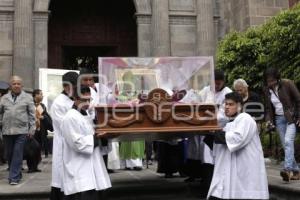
left=13, top=0, right=34, bottom=89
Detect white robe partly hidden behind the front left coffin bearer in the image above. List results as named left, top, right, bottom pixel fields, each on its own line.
left=50, top=94, right=74, bottom=190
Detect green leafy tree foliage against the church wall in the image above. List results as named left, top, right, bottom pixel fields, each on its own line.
left=217, top=4, right=300, bottom=91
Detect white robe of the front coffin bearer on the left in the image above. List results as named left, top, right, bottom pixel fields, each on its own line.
left=61, top=109, right=111, bottom=195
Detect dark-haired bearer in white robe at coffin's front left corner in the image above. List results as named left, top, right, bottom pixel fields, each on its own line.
left=61, top=86, right=111, bottom=200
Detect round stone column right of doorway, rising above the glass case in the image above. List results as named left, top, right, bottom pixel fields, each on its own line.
left=151, top=0, right=170, bottom=56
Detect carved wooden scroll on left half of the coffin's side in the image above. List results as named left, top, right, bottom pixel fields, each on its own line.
left=108, top=114, right=144, bottom=128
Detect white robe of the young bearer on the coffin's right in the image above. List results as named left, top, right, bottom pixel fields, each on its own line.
left=207, top=113, right=269, bottom=199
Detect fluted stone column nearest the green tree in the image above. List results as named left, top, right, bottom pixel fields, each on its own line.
left=196, top=0, right=215, bottom=56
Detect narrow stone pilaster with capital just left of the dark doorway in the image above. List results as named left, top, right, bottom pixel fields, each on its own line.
left=33, top=11, right=49, bottom=88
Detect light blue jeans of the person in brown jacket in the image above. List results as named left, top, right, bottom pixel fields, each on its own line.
left=275, top=115, right=299, bottom=171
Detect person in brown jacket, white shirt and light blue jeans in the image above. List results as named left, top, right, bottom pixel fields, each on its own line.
left=264, top=68, right=300, bottom=182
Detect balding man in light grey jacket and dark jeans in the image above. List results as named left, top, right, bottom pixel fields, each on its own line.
left=0, top=76, right=35, bottom=185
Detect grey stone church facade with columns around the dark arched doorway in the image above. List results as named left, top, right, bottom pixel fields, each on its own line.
left=0, top=0, right=296, bottom=88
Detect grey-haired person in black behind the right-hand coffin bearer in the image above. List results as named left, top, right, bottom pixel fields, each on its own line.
left=233, top=78, right=264, bottom=120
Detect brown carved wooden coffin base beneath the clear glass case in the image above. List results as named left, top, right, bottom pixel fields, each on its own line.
left=96, top=89, right=220, bottom=140
